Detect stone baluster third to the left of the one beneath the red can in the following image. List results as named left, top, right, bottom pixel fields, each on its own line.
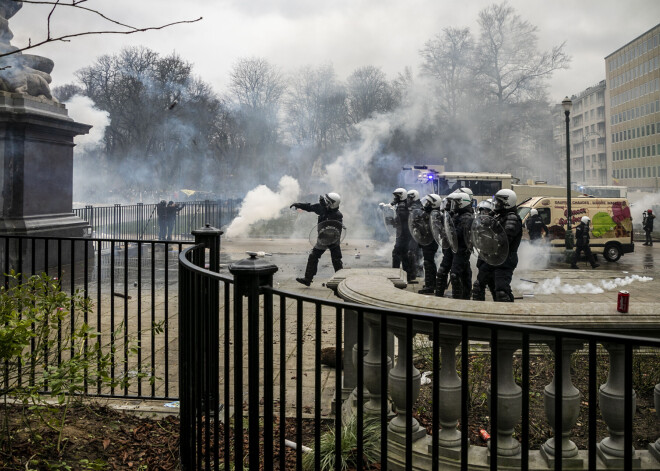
left=434, top=336, right=461, bottom=448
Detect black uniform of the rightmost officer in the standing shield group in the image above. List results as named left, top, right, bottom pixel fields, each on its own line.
left=473, top=207, right=522, bottom=303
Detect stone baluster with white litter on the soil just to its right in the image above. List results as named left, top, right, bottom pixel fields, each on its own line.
left=389, top=326, right=426, bottom=443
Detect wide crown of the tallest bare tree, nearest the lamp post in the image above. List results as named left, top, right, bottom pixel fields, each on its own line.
left=475, top=2, right=570, bottom=103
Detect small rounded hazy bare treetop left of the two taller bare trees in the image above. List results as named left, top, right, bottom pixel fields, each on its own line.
left=347, top=66, right=394, bottom=123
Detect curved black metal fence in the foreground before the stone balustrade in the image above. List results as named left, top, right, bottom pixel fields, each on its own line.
left=179, top=235, right=660, bottom=471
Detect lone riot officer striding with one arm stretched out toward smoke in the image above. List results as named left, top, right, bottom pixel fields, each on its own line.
left=290, top=193, right=344, bottom=286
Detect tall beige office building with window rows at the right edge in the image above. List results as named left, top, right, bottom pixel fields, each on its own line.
left=605, top=24, right=660, bottom=191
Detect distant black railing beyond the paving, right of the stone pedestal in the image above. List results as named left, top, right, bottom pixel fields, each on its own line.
left=73, top=199, right=241, bottom=241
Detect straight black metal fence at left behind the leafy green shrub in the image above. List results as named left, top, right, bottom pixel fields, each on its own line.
left=0, top=236, right=183, bottom=400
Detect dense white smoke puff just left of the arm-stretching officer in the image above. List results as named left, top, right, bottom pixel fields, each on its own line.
left=226, top=175, right=300, bottom=237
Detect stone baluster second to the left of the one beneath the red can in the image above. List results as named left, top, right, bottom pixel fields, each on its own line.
left=488, top=340, right=522, bottom=460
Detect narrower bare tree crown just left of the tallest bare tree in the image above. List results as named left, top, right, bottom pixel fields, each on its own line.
left=421, top=28, right=474, bottom=118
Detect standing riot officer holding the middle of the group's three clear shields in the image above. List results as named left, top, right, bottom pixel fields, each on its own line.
left=447, top=191, right=474, bottom=299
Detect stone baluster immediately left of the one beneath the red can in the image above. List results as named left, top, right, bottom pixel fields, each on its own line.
left=541, top=341, right=584, bottom=468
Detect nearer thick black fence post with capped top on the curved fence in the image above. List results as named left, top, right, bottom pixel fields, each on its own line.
left=229, top=252, right=277, bottom=471
